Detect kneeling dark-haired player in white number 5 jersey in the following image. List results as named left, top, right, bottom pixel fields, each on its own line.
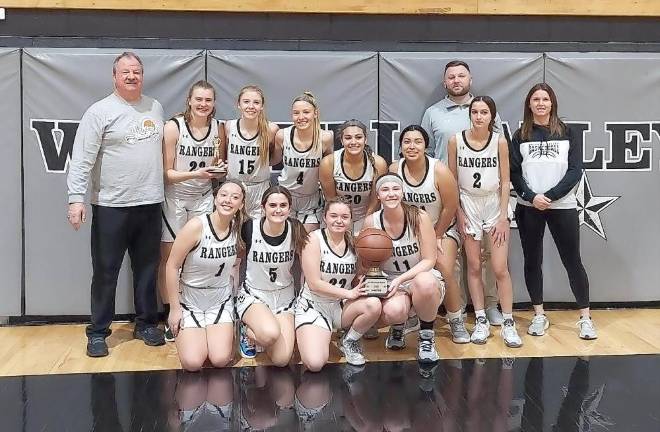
left=236, top=186, right=307, bottom=366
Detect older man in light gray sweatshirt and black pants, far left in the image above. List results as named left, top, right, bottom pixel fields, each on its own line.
left=67, top=52, right=165, bottom=357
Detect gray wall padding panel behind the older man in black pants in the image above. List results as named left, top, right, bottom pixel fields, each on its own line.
left=23, top=48, right=204, bottom=315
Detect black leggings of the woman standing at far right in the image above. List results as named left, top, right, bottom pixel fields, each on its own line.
left=516, top=204, right=589, bottom=309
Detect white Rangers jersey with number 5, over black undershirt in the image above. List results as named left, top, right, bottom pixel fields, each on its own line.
left=245, top=219, right=296, bottom=291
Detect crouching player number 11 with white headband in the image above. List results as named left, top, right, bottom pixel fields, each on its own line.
left=364, top=173, right=445, bottom=363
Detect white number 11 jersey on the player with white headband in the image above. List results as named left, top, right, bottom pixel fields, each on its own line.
left=373, top=210, right=422, bottom=282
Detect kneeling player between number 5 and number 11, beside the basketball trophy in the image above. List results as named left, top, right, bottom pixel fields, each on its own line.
left=296, top=198, right=381, bottom=372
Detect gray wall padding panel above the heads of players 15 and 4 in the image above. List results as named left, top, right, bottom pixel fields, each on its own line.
left=207, top=51, right=378, bottom=147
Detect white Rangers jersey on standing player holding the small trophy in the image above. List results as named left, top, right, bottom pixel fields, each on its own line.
left=165, top=116, right=218, bottom=198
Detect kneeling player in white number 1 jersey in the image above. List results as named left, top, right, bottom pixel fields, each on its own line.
left=165, top=181, right=246, bottom=371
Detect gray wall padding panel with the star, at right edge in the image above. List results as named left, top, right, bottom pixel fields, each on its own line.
left=545, top=53, right=660, bottom=301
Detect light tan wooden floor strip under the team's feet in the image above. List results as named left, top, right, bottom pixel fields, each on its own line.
left=0, top=309, right=660, bottom=376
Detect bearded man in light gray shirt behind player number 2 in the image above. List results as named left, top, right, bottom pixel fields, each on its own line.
left=422, top=60, right=504, bottom=325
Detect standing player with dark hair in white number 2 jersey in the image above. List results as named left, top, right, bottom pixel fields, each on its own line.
left=449, top=96, right=522, bottom=348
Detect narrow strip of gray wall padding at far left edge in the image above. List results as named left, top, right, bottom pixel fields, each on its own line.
left=0, top=48, right=23, bottom=316
